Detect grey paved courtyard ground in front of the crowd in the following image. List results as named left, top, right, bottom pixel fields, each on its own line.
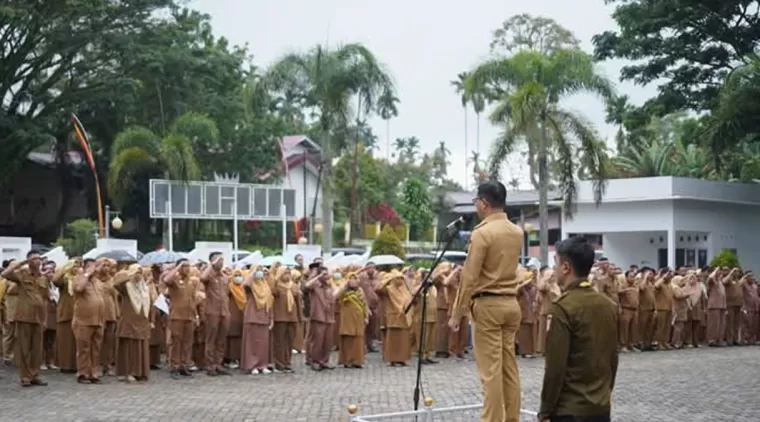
left=0, top=347, right=760, bottom=422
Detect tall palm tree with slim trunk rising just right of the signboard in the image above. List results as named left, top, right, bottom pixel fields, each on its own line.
left=265, top=44, right=395, bottom=253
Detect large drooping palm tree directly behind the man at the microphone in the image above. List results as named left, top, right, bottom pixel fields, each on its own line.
left=465, top=49, right=614, bottom=262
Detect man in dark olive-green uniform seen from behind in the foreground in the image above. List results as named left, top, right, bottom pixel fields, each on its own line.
left=538, top=237, right=618, bottom=422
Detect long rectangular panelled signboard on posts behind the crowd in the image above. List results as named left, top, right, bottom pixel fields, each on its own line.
left=150, top=179, right=298, bottom=221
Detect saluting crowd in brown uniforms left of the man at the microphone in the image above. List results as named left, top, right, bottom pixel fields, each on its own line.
left=0, top=251, right=476, bottom=386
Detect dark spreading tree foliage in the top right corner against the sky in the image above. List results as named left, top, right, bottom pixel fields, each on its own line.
left=593, top=0, right=760, bottom=116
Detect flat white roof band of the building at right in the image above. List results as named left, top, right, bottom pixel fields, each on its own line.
left=577, top=176, right=760, bottom=205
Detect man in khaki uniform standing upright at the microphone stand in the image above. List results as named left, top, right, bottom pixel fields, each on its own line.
left=449, top=181, right=523, bottom=422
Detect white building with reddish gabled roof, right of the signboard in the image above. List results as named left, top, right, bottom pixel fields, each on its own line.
left=280, top=135, right=322, bottom=220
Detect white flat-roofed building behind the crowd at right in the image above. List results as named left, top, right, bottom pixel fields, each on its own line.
left=562, top=177, right=760, bottom=271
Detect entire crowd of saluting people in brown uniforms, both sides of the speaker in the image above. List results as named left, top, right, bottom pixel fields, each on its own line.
left=0, top=247, right=760, bottom=386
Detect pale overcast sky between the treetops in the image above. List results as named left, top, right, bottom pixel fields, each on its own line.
left=190, top=0, right=656, bottom=188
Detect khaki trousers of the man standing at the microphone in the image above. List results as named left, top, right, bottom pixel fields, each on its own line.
left=470, top=296, right=522, bottom=422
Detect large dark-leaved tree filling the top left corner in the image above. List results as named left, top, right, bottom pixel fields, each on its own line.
left=0, top=0, right=173, bottom=176
